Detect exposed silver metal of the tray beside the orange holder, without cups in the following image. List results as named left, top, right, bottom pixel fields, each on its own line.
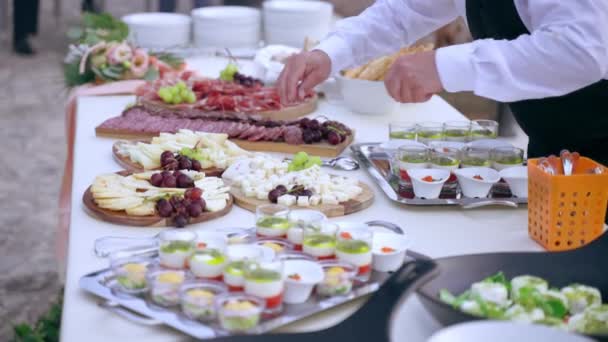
left=350, top=143, right=528, bottom=209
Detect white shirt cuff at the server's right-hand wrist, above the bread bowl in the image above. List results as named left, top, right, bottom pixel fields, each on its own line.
left=435, top=43, right=477, bottom=93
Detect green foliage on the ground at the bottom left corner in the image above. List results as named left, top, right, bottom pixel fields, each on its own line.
left=11, top=296, right=63, bottom=342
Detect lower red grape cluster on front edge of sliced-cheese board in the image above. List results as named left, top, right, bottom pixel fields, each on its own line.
left=156, top=188, right=206, bottom=228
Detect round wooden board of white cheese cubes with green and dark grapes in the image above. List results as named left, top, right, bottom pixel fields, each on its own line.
left=222, top=152, right=374, bottom=217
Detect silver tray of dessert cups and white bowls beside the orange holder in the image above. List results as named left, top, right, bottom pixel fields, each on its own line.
left=350, top=140, right=528, bottom=209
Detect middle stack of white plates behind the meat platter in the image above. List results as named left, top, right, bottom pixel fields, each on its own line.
left=192, top=6, right=262, bottom=48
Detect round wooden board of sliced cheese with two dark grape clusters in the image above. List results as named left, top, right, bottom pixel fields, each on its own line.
left=82, top=170, right=234, bottom=227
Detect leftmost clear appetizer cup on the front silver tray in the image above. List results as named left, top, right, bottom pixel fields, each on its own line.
left=110, top=252, right=154, bottom=295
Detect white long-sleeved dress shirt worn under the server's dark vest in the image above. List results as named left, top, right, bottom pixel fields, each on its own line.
left=317, top=0, right=608, bottom=102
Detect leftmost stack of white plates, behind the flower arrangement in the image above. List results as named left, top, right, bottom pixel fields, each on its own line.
left=122, top=12, right=191, bottom=49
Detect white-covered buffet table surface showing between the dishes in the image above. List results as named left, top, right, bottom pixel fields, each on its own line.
left=61, top=96, right=541, bottom=342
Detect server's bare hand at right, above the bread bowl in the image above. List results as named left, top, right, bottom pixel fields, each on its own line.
left=384, top=51, right=443, bottom=103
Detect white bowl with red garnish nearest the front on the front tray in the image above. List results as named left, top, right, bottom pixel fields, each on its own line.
left=283, top=259, right=324, bottom=304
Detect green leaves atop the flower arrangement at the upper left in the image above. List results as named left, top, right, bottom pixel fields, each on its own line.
left=68, top=13, right=129, bottom=45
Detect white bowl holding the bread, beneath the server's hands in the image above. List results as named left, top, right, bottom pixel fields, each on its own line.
left=336, top=75, right=399, bottom=115
